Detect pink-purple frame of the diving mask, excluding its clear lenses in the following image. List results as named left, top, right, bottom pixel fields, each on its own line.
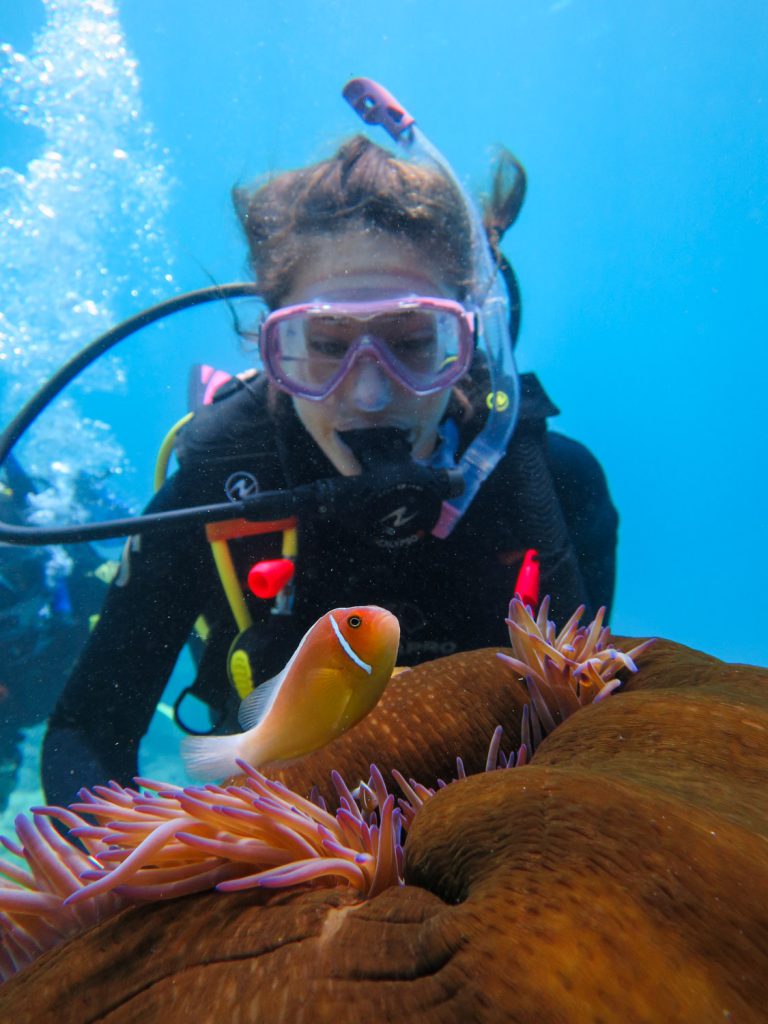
left=259, top=296, right=475, bottom=401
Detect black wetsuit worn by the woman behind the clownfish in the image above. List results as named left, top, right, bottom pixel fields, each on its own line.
left=43, top=375, right=617, bottom=803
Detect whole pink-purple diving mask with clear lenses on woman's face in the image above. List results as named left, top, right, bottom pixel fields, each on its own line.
left=260, top=296, right=474, bottom=401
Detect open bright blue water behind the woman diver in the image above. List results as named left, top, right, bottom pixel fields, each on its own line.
left=0, top=0, right=768, bottom=798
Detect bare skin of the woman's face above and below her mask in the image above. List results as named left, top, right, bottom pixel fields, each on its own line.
left=284, top=230, right=456, bottom=476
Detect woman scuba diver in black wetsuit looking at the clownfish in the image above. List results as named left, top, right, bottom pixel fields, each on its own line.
left=30, top=80, right=617, bottom=804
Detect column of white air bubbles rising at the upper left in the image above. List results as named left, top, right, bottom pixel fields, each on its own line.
left=0, top=0, right=173, bottom=519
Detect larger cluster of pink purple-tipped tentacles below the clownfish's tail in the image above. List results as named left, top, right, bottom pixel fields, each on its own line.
left=0, top=762, right=402, bottom=978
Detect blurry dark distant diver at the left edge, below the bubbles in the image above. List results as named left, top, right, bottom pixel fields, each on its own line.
left=0, top=456, right=112, bottom=810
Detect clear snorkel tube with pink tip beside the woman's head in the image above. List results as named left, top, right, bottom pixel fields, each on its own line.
left=342, top=78, right=520, bottom=539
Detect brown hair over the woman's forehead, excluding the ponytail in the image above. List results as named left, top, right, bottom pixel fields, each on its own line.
left=232, top=135, right=472, bottom=309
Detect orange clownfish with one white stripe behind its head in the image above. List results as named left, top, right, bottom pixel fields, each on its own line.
left=181, top=605, right=400, bottom=780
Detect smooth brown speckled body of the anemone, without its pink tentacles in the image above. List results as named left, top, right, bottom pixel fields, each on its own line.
left=0, top=626, right=768, bottom=1024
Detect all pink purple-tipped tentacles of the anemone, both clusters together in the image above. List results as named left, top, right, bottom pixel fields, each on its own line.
left=0, top=599, right=647, bottom=978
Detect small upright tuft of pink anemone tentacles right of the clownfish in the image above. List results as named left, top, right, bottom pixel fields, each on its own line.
left=498, top=597, right=653, bottom=754
